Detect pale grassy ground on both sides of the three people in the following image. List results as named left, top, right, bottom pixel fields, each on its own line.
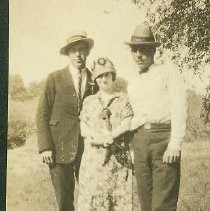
left=7, top=135, right=210, bottom=211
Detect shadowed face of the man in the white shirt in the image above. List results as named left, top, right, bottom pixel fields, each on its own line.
left=131, top=45, right=155, bottom=72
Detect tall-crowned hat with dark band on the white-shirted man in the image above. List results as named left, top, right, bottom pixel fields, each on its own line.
left=125, top=25, right=160, bottom=47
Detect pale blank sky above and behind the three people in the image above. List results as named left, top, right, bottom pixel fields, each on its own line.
left=9, top=0, right=206, bottom=92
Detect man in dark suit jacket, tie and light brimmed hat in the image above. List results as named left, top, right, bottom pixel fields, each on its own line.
left=36, top=31, right=94, bottom=211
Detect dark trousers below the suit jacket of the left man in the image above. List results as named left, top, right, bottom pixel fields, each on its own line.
left=50, top=162, right=75, bottom=211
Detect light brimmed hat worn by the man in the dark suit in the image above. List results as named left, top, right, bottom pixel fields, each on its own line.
left=60, top=31, right=94, bottom=55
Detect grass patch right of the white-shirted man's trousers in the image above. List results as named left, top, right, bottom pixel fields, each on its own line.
left=178, top=140, right=210, bottom=211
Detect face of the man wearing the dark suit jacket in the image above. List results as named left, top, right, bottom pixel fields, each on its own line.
left=68, top=42, right=89, bottom=69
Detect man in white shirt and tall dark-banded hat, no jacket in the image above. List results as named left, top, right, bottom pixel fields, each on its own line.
left=126, top=25, right=186, bottom=211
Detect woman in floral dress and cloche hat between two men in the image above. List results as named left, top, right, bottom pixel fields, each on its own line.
left=78, top=58, right=133, bottom=211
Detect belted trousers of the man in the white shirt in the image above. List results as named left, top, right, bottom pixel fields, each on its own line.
left=133, top=128, right=180, bottom=211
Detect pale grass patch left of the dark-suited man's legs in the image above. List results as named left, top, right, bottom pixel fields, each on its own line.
left=7, top=136, right=57, bottom=211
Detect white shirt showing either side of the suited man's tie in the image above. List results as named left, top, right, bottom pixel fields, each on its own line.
left=69, top=64, right=87, bottom=97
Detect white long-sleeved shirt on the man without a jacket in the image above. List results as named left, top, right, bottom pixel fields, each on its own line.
left=128, top=64, right=187, bottom=150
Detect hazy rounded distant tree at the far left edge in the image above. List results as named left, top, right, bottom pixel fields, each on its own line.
left=9, top=74, right=26, bottom=101
